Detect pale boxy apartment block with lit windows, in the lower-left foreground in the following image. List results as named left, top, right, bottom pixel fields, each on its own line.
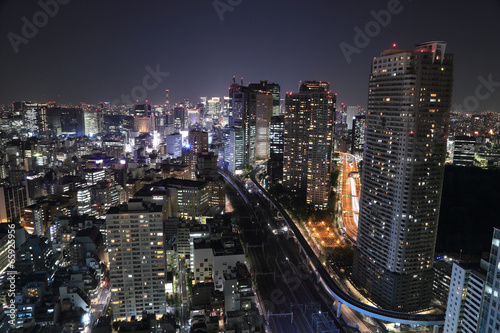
left=106, top=199, right=166, bottom=320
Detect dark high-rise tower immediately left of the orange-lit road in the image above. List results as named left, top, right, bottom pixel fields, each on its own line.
left=283, top=81, right=336, bottom=209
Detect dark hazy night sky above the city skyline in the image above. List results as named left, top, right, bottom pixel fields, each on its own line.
left=0, top=0, right=500, bottom=111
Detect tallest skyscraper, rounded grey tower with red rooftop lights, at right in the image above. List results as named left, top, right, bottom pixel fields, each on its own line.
left=353, top=42, right=453, bottom=311
